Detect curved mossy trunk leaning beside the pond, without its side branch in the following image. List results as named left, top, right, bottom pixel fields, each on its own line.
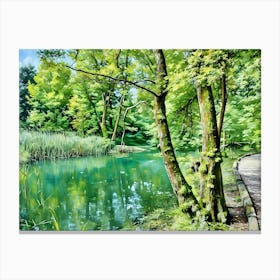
left=154, top=50, right=198, bottom=216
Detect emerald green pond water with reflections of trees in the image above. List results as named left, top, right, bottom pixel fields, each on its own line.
left=20, top=152, right=176, bottom=230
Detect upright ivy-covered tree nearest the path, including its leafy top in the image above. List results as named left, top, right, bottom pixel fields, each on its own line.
left=188, top=50, right=228, bottom=222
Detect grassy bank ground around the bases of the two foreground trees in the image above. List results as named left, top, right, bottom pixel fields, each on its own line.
left=123, top=150, right=260, bottom=232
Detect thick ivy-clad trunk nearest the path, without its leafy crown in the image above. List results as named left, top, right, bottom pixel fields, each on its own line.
left=197, top=86, right=228, bottom=222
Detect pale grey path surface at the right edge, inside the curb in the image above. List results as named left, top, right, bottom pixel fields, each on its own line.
left=238, top=154, right=261, bottom=228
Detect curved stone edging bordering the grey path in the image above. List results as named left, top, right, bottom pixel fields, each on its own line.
left=233, top=154, right=260, bottom=231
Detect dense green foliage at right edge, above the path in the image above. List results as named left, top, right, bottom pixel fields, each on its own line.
left=224, top=50, right=261, bottom=152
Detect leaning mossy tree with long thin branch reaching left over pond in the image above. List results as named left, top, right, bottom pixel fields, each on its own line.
left=69, top=50, right=198, bottom=216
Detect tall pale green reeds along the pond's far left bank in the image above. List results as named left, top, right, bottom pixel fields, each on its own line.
left=19, top=131, right=113, bottom=162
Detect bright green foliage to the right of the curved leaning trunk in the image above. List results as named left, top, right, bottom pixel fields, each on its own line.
left=166, top=50, right=261, bottom=151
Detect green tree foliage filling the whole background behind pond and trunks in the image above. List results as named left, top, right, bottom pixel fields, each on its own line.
left=20, top=49, right=261, bottom=153
